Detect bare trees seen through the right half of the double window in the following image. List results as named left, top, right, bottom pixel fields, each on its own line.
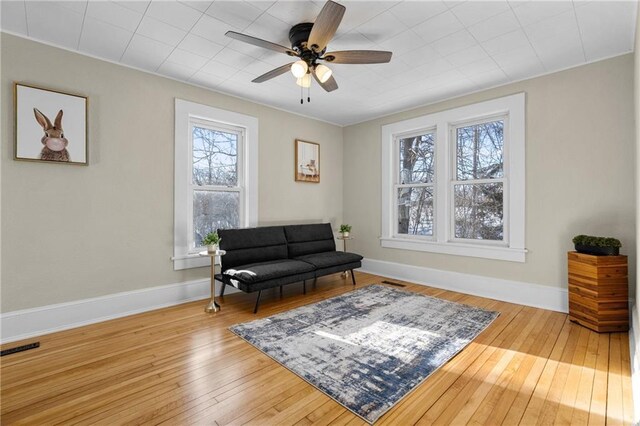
left=453, top=120, right=504, bottom=241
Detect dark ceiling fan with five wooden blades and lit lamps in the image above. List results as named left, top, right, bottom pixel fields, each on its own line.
left=225, top=0, right=392, bottom=103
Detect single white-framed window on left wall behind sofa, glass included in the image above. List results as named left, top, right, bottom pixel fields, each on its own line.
left=173, top=99, right=258, bottom=269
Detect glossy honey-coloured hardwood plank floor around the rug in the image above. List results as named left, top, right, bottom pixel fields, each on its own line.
left=0, top=273, right=633, bottom=426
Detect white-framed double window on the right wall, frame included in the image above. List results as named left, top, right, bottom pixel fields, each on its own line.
left=381, top=94, right=526, bottom=262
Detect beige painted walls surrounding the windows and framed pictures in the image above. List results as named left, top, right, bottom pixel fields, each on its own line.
left=0, top=34, right=636, bottom=312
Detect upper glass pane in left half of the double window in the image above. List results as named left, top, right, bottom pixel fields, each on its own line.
left=399, top=133, right=435, bottom=184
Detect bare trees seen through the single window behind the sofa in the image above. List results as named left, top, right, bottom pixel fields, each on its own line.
left=192, top=126, right=240, bottom=247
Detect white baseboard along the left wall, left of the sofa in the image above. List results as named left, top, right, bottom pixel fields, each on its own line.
left=0, top=278, right=239, bottom=343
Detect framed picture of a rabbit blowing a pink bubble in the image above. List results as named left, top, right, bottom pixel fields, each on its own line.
left=14, top=83, right=88, bottom=166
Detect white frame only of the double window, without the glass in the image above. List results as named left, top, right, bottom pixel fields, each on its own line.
left=380, top=93, right=527, bottom=262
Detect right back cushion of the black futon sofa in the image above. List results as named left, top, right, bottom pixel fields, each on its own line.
left=284, top=223, right=336, bottom=259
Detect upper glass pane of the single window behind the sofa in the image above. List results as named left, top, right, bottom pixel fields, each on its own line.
left=192, top=126, right=238, bottom=186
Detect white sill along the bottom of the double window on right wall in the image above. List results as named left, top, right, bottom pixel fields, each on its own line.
left=380, top=237, right=527, bottom=262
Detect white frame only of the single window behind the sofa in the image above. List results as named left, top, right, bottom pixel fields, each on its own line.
left=172, top=98, right=258, bottom=270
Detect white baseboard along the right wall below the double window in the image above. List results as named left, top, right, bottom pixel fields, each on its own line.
left=361, top=259, right=569, bottom=312
